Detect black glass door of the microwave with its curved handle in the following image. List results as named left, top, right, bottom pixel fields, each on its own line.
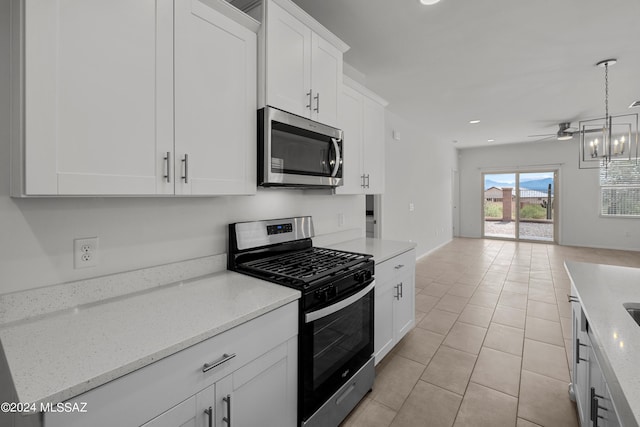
left=271, top=122, right=336, bottom=176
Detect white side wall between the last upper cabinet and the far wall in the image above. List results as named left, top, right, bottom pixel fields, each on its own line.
left=382, top=111, right=457, bottom=256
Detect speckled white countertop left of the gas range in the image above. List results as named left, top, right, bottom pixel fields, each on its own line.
left=0, top=271, right=300, bottom=410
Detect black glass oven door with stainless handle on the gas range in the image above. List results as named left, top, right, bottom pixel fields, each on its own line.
left=299, top=279, right=375, bottom=420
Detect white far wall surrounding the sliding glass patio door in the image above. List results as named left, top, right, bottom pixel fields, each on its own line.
left=459, top=137, right=640, bottom=250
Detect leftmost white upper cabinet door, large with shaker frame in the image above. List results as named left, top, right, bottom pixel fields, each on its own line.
left=23, top=0, right=173, bottom=195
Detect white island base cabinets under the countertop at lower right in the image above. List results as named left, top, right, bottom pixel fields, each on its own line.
left=571, top=286, right=620, bottom=427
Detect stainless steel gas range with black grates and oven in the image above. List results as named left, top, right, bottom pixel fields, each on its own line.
left=228, top=217, right=375, bottom=427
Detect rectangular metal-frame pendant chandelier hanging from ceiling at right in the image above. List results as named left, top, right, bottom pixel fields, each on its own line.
left=578, top=59, right=638, bottom=169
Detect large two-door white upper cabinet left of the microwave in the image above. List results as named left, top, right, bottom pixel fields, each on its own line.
left=11, top=0, right=258, bottom=196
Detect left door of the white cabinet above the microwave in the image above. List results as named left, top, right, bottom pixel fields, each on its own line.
left=265, top=1, right=312, bottom=117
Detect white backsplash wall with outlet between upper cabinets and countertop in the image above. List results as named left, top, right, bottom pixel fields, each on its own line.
left=0, top=189, right=364, bottom=294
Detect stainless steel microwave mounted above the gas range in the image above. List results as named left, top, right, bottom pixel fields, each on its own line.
left=258, top=106, right=343, bottom=187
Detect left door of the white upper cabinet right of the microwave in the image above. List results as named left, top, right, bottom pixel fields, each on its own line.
left=336, top=86, right=364, bottom=194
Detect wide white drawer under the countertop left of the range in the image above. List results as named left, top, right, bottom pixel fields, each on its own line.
left=44, top=301, right=298, bottom=427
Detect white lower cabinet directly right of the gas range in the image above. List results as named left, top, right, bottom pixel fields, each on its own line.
left=373, top=249, right=416, bottom=364
